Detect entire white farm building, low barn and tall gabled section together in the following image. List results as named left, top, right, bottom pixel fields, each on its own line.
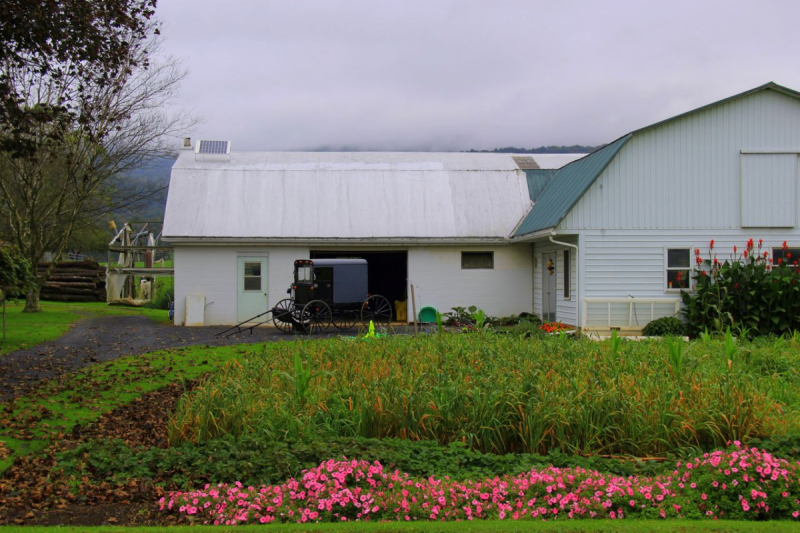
left=164, top=83, right=800, bottom=330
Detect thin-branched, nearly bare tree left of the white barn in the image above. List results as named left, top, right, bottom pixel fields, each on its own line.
left=0, top=28, right=197, bottom=312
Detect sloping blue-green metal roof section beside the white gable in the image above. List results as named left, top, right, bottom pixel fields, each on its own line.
left=514, top=134, right=631, bottom=237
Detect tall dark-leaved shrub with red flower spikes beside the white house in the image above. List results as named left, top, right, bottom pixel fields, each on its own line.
left=682, top=239, right=800, bottom=337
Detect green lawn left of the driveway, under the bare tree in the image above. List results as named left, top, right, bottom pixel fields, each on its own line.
left=0, top=300, right=168, bottom=356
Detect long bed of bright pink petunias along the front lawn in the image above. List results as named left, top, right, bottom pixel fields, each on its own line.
left=159, top=443, right=800, bottom=525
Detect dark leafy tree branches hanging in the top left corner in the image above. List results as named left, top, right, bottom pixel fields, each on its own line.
left=0, top=0, right=158, bottom=158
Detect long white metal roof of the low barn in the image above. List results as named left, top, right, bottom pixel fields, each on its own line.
left=163, top=150, right=535, bottom=243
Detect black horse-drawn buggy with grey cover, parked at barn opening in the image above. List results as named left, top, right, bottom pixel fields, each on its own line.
left=272, top=259, right=392, bottom=333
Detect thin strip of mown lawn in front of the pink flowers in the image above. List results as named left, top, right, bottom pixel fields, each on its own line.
left=0, top=519, right=799, bottom=533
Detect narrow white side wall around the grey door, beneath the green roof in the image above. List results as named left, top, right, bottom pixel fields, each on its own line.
left=533, top=235, right=578, bottom=326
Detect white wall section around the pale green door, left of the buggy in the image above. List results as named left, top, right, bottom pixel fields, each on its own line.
left=175, top=246, right=309, bottom=325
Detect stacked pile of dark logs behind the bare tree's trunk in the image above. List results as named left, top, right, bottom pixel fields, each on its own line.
left=39, top=259, right=106, bottom=302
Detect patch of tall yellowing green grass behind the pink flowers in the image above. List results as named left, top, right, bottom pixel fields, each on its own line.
left=169, top=333, right=800, bottom=456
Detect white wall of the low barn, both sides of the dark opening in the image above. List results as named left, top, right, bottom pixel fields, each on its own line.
left=175, top=244, right=533, bottom=325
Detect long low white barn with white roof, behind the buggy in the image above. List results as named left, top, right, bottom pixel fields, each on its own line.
left=164, top=150, right=580, bottom=325
